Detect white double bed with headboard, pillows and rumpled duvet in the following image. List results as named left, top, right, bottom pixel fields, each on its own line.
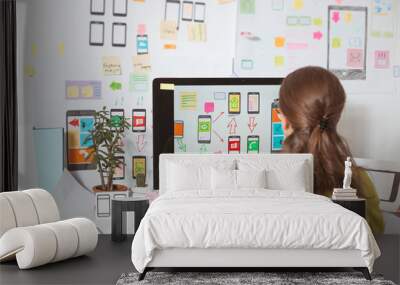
left=132, top=154, right=380, bottom=278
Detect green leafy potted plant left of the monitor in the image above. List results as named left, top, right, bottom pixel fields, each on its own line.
left=87, top=106, right=130, bottom=192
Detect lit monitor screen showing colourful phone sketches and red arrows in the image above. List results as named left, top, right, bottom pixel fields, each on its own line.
left=174, top=85, right=283, bottom=153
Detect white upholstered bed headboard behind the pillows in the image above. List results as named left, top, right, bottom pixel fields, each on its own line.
left=159, top=153, right=314, bottom=195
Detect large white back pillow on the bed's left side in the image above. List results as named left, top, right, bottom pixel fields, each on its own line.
left=166, top=160, right=236, bottom=191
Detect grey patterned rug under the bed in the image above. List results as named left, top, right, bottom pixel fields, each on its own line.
left=117, top=272, right=395, bottom=285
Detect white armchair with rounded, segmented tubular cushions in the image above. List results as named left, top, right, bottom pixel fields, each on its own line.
left=0, top=189, right=97, bottom=269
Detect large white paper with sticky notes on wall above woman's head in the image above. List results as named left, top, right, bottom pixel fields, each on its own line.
left=234, top=0, right=399, bottom=94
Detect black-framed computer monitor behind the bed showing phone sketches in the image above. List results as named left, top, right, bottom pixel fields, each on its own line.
left=153, top=78, right=284, bottom=189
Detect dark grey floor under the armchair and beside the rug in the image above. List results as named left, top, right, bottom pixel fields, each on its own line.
left=0, top=235, right=400, bottom=285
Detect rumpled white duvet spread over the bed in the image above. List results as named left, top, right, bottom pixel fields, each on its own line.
left=132, top=189, right=380, bottom=272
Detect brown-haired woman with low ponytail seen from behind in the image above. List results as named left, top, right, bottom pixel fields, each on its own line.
left=279, top=66, right=384, bottom=233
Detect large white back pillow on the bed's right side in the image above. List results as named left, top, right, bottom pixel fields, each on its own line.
left=238, top=158, right=308, bottom=191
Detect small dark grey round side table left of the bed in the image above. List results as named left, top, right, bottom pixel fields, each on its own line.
left=111, top=195, right=149, bottom=241
